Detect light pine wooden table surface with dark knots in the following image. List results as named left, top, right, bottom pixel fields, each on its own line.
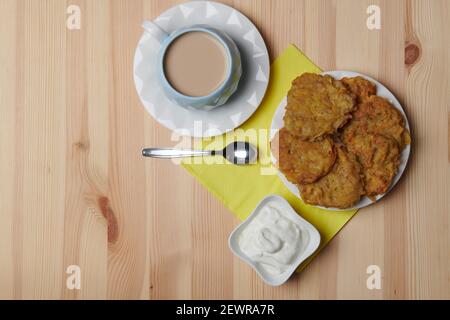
left=0, top=0, right=450, bottom=299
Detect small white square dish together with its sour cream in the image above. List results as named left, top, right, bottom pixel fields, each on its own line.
left=228, top=195, right=320, bottom=286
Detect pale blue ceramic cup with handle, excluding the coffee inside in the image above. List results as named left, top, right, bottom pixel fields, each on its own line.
left=142, top=21, right=242, bottom=110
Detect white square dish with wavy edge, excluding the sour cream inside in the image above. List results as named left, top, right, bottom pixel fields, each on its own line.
left=228, top=195, right=320, bottom=286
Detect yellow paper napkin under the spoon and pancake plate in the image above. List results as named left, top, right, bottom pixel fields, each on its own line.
left=182, top=45, right=356, bottom=269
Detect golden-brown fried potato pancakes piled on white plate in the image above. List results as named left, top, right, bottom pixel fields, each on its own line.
left=271, top=73, right=410, bottom=209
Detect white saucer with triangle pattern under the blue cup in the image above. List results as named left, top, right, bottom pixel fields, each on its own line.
left=134, top=1, right=270, bottom=137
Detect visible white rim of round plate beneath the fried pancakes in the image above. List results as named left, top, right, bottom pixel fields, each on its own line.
left=270, top=71, right=411, bottom=211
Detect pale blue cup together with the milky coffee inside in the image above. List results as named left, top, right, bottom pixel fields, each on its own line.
left=142, top=21, right=242, bottom=110
